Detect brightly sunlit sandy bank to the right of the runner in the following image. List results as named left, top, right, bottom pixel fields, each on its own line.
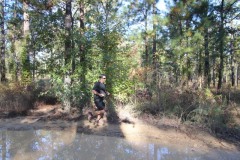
left=118, top=107, right=238, bottom=151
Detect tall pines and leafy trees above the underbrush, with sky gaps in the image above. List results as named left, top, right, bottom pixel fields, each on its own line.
left=0, top=0, right=240, bottom=107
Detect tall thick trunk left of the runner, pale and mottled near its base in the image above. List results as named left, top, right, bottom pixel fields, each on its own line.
left=63, top=0, right=73, bottom=112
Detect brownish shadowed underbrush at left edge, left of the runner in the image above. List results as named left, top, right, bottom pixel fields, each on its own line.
left=0, top=80, right=58, bottom=116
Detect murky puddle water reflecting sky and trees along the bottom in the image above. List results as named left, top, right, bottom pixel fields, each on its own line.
left=0, top=127, right=240, bottom=160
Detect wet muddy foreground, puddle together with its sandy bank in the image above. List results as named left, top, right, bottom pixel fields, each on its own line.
left=0, top=117, right=240, bottom=160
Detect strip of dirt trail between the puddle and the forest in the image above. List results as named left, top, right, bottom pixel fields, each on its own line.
left=0, top=105, right=240, bottom=152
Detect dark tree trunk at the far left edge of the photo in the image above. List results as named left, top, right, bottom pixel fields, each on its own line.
left=0, top=0, right=6, bottom=82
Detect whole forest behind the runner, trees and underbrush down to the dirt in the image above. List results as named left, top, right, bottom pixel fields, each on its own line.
left=0, top=0, right=240, bottom=138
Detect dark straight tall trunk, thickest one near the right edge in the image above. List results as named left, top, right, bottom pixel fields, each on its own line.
left=218, top=0, right=224, bottom=90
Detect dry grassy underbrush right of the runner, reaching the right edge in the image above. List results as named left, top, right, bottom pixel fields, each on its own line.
left=134, top=86, right=240, bottom=139
